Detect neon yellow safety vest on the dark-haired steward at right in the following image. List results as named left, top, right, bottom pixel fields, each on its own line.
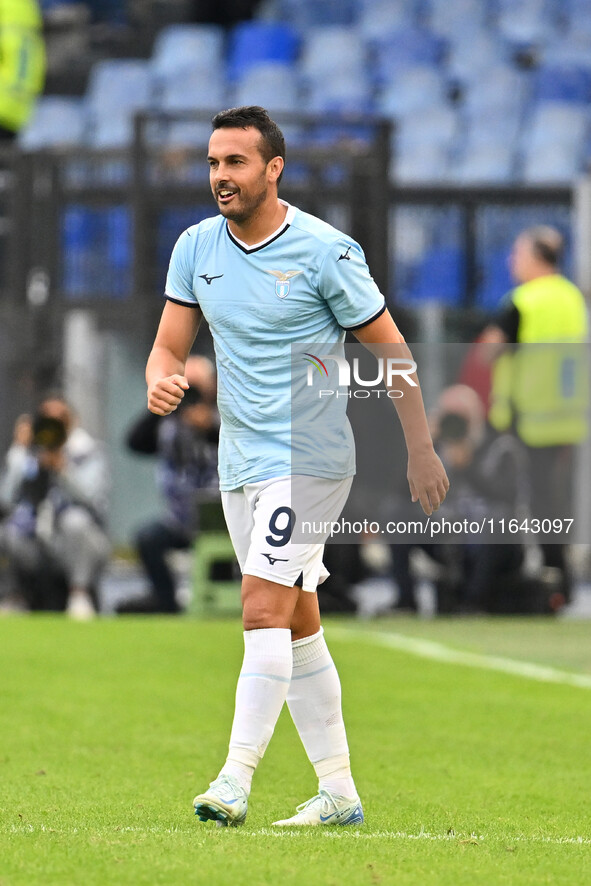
left=489, top=274, right=589, bottom=447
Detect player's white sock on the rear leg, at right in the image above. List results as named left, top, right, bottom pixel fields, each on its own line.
left=287, top=628, right=357, bottom=797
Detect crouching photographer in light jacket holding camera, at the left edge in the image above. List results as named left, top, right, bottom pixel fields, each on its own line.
left=3, top=396, right=110, bottom=620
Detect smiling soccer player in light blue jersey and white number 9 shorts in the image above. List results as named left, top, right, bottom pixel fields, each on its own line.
left=146, top=106, right=449, bottom=825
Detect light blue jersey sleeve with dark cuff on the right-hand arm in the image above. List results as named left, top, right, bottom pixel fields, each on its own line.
left=319, top=238, right=386, bottom=330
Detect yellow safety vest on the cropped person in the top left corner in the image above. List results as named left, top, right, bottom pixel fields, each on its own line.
left=0, top=0, right=45, bottom=132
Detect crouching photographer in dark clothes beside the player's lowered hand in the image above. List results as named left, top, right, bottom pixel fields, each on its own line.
left=390, top=384, right=529, bottom=614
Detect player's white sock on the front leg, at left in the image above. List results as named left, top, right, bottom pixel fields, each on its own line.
left=220, top=628, right=292, bottom=793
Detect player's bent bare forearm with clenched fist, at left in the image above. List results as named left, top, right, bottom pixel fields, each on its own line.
left=146, top=301, right=201, bottom=415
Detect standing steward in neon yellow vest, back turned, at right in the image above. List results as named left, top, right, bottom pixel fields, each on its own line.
left=483, top=226, right=589, bottom=600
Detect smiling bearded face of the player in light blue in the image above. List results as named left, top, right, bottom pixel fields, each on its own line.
left=207, top=126, right=283, bottom=225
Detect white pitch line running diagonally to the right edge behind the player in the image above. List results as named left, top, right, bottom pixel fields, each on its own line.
left=329, top=627, right=591, bottom=689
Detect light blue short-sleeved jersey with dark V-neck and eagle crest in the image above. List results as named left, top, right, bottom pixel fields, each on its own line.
left=166, top=206, right=385, bottom=490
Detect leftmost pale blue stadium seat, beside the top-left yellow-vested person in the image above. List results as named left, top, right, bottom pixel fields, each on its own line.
left=18, top=95, right=86, bottom=151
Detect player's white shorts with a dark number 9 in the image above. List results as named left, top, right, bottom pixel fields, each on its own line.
left=222, top=477, right=353, bottom=592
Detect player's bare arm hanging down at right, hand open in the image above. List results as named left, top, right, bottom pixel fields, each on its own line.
left=355, top=311, right=449, bottom=515
